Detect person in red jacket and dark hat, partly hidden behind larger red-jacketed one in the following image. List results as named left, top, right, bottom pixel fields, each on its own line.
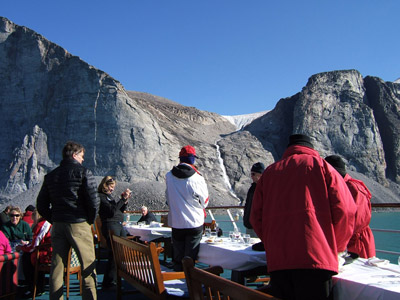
left=325, top=155, right=376, bottom=258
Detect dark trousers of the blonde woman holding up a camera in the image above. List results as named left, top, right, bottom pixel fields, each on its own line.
left=101, top=222, right=126, bottom=287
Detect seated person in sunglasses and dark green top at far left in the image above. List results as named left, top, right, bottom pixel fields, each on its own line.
left=2, top=207, right=32, bottom=249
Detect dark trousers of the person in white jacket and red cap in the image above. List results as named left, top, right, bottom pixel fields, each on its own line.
left=172, top=226, right=203, bottom=271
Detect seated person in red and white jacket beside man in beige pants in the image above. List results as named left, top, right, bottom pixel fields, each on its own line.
left=16, top=210, right=52, bottom=297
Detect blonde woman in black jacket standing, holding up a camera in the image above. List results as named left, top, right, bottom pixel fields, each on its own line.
left=97, top=176, right=131, bottom=289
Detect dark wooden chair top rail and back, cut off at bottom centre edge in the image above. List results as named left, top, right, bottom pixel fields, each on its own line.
left=183, top=257, right=278, bottom=300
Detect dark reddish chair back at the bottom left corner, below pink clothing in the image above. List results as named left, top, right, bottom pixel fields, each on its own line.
left=0, top=252, right=20, bottom=299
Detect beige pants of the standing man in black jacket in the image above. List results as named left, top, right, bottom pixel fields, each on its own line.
left=50, top=222, right=97, bottom=300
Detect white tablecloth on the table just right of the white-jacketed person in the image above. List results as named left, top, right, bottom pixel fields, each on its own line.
left=197, top=238, right=267, bottom=271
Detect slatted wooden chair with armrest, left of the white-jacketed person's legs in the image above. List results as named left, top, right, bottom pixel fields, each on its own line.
left=111, top=235, right=185, bottom=300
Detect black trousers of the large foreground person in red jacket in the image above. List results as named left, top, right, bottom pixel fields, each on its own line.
left=263, top=269, right=334, bottom=300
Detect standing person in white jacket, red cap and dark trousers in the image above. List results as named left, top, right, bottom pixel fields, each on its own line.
left=166, top=145, right=208, bottom=271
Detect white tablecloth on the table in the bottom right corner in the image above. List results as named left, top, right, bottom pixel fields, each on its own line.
left=333, top=258, right=400, bottom=300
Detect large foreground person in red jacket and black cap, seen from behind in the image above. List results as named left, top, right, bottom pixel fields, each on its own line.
left=250, top=134, right=356, bottom=300
